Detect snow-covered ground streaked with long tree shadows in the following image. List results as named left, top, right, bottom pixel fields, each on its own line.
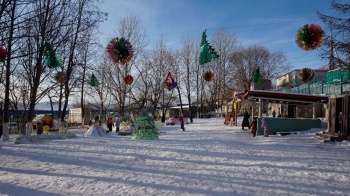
left=0, top=118, right=350, bottom=196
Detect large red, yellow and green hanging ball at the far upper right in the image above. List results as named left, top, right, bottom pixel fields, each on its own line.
left=295, top=24, right=324, bottom=50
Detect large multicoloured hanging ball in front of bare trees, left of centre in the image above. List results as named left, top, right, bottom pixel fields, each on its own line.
left=106, top=37, right=134, bottom=65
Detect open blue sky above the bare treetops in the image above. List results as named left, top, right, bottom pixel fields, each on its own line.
left=100, top=0, right=344, bottom=69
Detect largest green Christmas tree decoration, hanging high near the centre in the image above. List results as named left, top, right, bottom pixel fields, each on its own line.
left=199, top=30, right=219, bottom=65
